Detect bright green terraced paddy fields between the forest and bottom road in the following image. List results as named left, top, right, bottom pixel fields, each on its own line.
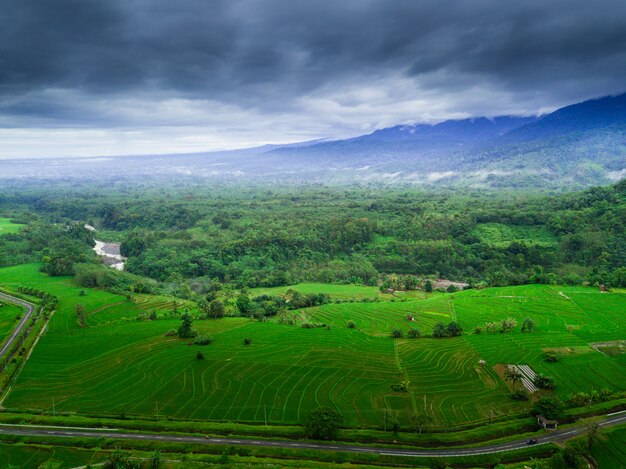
left=0, top=265, right=626, bottom=426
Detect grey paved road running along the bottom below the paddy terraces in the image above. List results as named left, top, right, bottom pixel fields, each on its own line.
left=0, top=411, right=626, bottom=457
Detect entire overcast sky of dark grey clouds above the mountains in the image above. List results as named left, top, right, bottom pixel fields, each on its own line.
left=0, top=0, right=626, bottom=158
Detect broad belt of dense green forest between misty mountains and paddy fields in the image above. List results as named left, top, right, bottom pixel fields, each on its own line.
left=0, top=181, right=626, bottom=290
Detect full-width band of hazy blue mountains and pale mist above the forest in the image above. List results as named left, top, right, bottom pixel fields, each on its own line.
left=0, top=94, right=626, bottom=189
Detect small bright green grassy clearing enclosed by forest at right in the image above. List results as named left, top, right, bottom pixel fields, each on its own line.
left=472, top=223, right=557, bottom=247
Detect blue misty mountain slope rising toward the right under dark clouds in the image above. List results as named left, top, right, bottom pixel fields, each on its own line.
left=263, top=94, right=626, bottom=188
